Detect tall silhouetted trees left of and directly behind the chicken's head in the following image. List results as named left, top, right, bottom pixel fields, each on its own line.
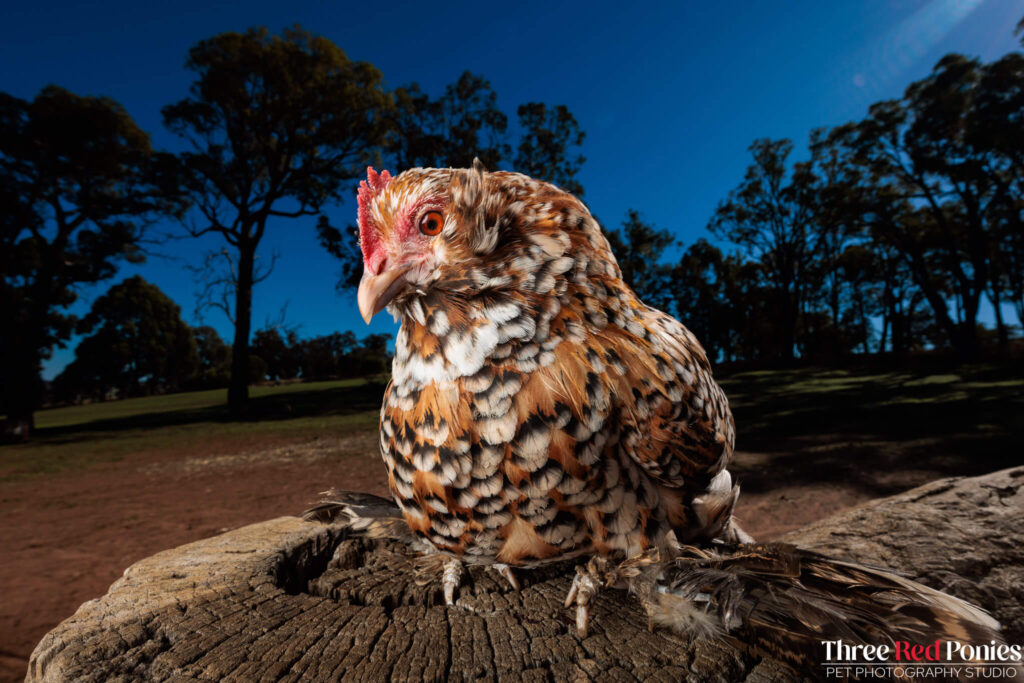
left=0, top=27, right=584, bottom=438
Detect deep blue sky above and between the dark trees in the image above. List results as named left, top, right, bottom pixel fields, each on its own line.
left=0, top=0, right=1024, bottom=377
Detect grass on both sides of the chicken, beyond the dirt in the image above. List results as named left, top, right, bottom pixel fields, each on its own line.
left=0, top=366, right=1024, bottom=496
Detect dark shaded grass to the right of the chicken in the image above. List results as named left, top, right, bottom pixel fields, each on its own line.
left=723, top=367, right=1024, bottom=497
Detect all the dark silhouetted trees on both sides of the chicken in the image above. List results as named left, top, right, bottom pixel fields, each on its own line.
left=0, top=22, right=1024, bottom=438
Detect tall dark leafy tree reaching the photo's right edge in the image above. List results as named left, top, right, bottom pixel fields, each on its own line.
left=819, top=54, right=1024, bottom=358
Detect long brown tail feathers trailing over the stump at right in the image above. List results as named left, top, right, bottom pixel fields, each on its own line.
left=617, top=543, right=1002, bottom=673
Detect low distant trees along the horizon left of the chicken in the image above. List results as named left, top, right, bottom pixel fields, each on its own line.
left=49, top=275, right=391, bottom=402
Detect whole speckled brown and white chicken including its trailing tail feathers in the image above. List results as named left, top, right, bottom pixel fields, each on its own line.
left=306, top=162, right=1002, bottom=673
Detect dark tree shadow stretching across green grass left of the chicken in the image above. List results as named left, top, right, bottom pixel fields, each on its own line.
left=34, top=380, right=387, bottom=444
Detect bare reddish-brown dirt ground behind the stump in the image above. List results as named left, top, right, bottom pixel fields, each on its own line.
left=0, top=433, right=880, bottom=681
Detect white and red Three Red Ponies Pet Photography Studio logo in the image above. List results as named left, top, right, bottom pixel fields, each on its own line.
left=821, top=640, right=1024, bottom=681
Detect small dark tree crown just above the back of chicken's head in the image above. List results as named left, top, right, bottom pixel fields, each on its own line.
left=515, top=102, right=587, bottom=197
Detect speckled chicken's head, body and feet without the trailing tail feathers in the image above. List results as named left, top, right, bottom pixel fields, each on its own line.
left=350, top=157, right=745, bottom=632
